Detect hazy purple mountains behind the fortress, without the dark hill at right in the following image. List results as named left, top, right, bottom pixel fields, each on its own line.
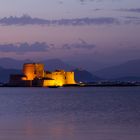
left=0, top=58, right=75, bottom=82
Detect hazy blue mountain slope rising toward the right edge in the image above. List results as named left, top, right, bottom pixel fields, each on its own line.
left=93, top=59, right=140, bottom=79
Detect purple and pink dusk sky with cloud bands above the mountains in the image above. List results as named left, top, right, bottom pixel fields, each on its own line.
left=0, top=0, right=140, bottom=69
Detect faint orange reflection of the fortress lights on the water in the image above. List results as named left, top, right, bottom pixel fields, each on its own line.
left=24, top=120, right=75, bottom=140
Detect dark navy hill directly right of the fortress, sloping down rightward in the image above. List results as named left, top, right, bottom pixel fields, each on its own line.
left=73, top=69, right=100, bottom=82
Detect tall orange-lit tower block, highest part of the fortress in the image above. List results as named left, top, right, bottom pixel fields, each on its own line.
left=23, top=63, right=44, bottom=80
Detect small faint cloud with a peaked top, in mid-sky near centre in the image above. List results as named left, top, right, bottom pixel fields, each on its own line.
left=62, top=39, right=96, bottom=50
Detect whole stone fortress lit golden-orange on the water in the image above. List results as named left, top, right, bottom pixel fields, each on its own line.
left=9, top=63, right=76, bottom=87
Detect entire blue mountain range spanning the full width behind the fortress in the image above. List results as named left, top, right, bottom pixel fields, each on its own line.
left=0, top=58, right=140, bottom=83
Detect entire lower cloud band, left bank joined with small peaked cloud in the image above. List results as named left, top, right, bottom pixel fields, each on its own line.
left=0, top=39, right=96, bottom=54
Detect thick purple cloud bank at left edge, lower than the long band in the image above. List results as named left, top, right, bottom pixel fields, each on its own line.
left=0, top=42, right=49, bottom=53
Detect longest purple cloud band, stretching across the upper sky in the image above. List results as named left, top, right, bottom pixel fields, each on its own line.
left=0, top=15, right=119, bottom=26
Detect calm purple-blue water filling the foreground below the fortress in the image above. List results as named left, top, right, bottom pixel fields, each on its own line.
left=0, top=87, right=140, bottom=140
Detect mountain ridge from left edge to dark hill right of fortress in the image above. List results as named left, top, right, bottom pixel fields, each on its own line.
left=0, top=58, right=99, bottom=82
